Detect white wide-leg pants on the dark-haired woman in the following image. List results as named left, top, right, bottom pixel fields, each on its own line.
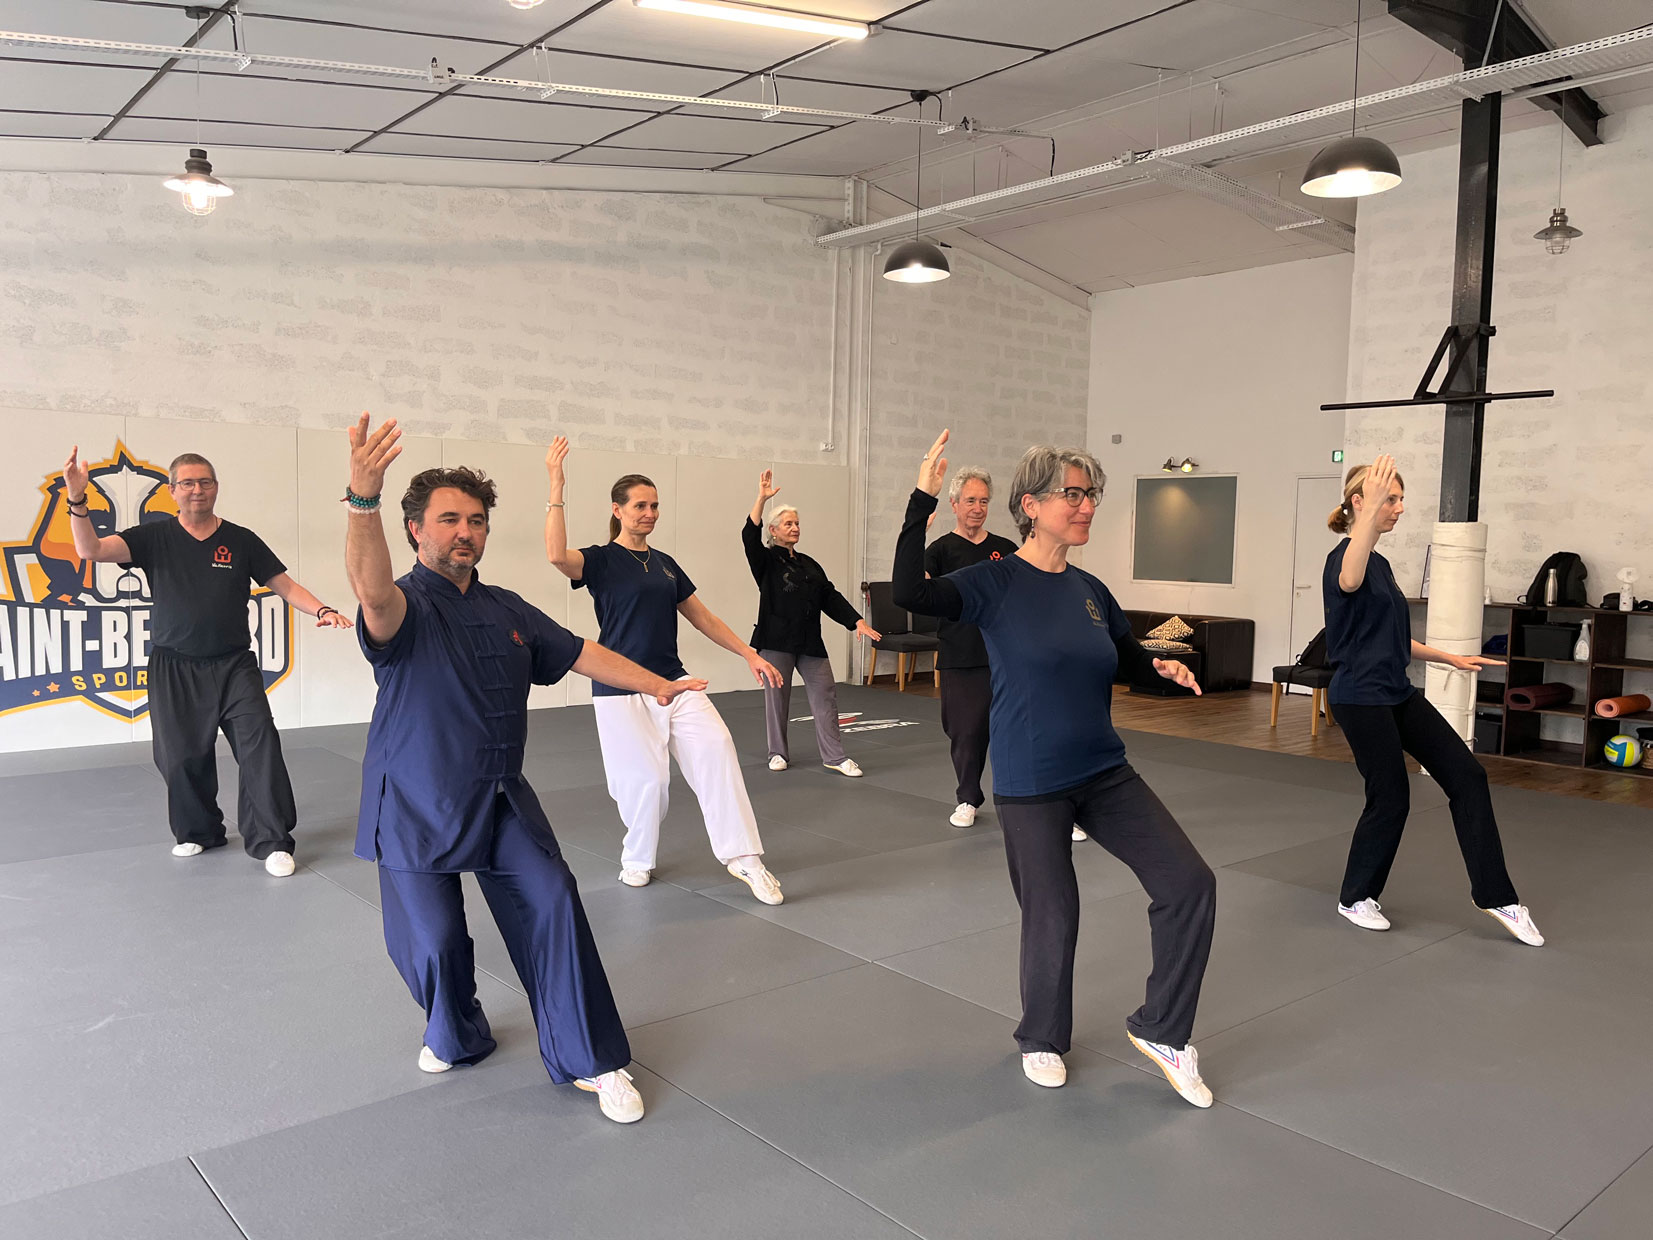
left=592, top=693, right=764, bottom=870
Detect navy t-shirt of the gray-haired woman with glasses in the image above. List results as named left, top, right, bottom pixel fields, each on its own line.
left=946, top=556, right=1131, bottom=800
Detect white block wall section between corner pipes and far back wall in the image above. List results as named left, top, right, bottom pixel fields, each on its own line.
left=866, top=250, right=1091, bottom=579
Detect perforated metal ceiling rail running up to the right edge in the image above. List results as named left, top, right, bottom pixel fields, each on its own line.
left=815, top=26, right=1653, bottom=246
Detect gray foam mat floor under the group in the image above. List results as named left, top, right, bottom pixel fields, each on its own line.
left=0, top=684, right=1653, bottom=1240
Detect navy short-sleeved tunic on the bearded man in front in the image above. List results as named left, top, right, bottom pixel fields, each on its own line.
left=355, top=564, right=585, bottom=873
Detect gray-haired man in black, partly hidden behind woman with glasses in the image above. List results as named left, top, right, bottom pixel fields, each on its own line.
left=924, top=466, right=1017, bottom=827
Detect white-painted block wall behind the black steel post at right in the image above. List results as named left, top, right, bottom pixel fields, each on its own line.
left=1346, top=107, right=1653, bottom=600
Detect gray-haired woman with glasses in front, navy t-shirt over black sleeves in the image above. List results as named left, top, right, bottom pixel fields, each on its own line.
left=891, top=430, right=1217, bottom=1106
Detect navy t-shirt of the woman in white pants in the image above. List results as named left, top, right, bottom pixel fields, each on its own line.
left=574, top=542, right=694, bottom=698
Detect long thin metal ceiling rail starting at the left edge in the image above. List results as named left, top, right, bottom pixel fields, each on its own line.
left=0, top=30, right=944, bottom=129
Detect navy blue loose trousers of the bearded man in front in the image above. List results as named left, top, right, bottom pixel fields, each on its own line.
left=379, top=797, right=631, bottom=1085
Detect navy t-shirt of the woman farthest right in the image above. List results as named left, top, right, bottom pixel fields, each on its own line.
left=1321, top=539, right=1413, bottom=706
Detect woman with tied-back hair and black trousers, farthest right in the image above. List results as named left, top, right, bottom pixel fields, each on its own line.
left=1321, top=456, right=1544, bottom=947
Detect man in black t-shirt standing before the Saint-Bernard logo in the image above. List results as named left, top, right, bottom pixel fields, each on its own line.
left=63, top=446, right=350, bottom=878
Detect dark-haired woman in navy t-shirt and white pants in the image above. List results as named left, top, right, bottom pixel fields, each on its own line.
left=545, top=435, right=782, bottom=904
